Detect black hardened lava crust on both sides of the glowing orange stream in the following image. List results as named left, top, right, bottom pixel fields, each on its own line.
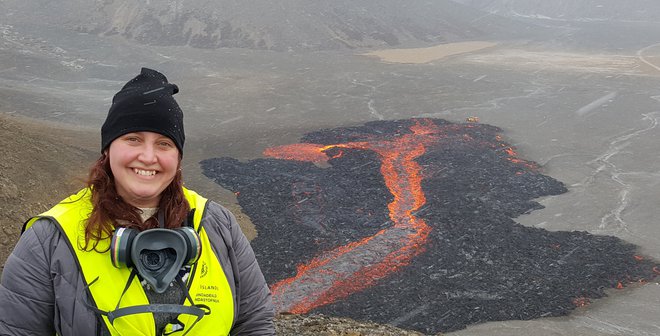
left=201, top=119, right=657, bottom=333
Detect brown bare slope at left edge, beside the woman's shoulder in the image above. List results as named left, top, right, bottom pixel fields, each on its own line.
left=0, top=114, right=98, bottom=268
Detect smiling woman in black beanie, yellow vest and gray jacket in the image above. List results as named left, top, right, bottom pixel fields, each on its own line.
left=0, top=68, right=275, bottom=336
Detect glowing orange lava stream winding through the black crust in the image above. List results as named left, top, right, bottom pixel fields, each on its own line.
left=264, top=120, right=438, bottom=314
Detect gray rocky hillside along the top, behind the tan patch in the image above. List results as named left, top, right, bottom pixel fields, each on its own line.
left=0, top=0, right=530, bottom=51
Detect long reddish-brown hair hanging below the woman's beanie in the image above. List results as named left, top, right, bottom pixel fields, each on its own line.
left=82, top=153, right=190, bottom=252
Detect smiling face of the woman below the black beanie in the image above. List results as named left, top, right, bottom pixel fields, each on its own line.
left=108, top=132, right=179, bottom=208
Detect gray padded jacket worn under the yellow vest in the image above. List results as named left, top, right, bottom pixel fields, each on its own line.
left=0, top=201, right=275, bottom=336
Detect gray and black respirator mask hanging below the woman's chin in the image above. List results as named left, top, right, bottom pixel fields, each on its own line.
left=110, top=226, right=201, bottom=293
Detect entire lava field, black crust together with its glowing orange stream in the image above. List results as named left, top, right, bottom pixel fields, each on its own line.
left=201, top=119, right=659, bottom=333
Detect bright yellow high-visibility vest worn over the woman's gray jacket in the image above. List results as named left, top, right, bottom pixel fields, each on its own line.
left=24, top=188, right=234, bottom=336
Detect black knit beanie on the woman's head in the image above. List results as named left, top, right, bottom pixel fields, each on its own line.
left=101, top=68, right=186, bottom=155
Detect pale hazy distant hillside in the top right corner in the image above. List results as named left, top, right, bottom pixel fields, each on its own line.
left=454, top=0, right=660, bottom=22
